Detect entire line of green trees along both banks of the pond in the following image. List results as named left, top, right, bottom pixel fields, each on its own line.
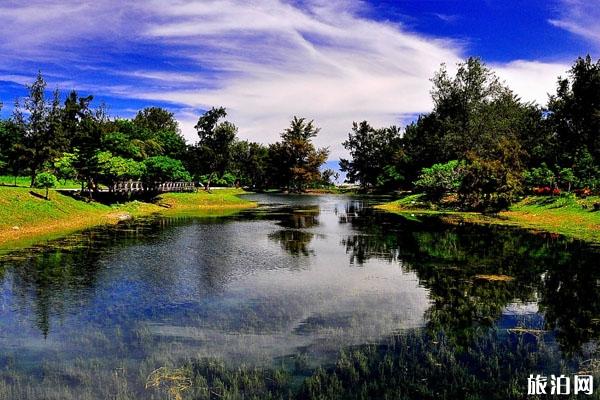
left=0, top=56, right=600, bottom=209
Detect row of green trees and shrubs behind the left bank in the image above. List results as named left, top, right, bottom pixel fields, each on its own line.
left=0, top=74, right=334, bottom=193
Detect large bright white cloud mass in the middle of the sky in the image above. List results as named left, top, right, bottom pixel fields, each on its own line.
left=138, top=0, right=461, bottom=158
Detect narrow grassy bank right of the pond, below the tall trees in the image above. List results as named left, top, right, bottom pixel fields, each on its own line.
left=376, top=195, right=600, bottom=243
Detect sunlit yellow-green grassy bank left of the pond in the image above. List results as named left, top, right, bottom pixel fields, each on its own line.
left=0, top=187, right=256, bottom=249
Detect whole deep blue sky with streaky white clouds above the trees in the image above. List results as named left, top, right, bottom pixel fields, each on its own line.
left=0, top=0, right=600, bottom=160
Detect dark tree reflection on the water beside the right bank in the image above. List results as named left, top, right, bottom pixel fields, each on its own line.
left=342, top=209, right=600, bottom=354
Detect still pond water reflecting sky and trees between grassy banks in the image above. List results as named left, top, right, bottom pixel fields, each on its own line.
left=0, top=195, right=600, bottom=399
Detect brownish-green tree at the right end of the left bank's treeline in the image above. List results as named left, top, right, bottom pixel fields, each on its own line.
left=269, top=117, right=329, bottom=191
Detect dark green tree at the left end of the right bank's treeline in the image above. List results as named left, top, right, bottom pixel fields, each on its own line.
left=340, top=121, right=404, bottom=190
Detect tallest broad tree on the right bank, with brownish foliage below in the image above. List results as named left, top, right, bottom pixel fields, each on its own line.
left=403, top=58, right=540, bottom=208
